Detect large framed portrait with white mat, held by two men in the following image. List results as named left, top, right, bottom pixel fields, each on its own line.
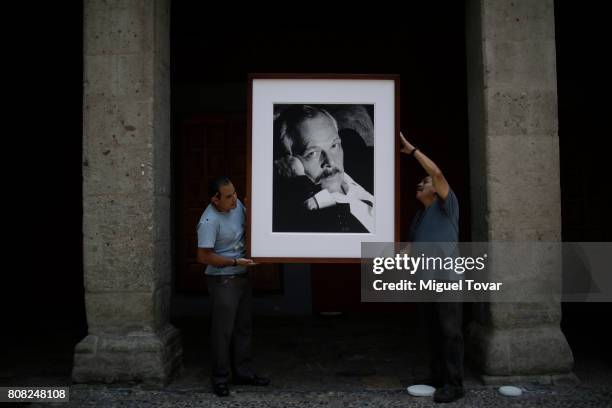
left=247, top=74, right=399, bottom=262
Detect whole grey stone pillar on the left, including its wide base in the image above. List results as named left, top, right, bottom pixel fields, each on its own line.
left=72, top=0, right=182, bottom=385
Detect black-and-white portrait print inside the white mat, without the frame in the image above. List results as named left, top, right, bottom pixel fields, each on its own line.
left=271, top=104, right=376, bottom=234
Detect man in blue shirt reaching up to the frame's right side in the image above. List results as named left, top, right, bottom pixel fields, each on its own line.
left=400, top=132, right=464, bottom=402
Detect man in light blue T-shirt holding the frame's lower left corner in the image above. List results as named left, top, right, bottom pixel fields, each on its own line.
left=197, top=177, right=270, bottom=397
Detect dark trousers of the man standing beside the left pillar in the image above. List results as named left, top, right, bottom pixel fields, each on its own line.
left=207, top=273, right=254, bottom=384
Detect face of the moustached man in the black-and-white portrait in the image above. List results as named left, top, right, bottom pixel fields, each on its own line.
left=294, top=115, right=344, bottom=193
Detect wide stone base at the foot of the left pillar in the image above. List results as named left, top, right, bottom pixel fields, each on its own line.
left=72, top=325, right=183, bottom=387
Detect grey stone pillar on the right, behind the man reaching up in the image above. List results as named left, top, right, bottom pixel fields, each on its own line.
left=466, top=0, right=573, bottom=383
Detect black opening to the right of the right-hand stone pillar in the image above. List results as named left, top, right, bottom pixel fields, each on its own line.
left=555, top=1, right=612, bottom=365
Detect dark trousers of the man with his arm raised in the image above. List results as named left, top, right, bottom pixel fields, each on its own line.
left=421, top=302, right=463, bottom=386
